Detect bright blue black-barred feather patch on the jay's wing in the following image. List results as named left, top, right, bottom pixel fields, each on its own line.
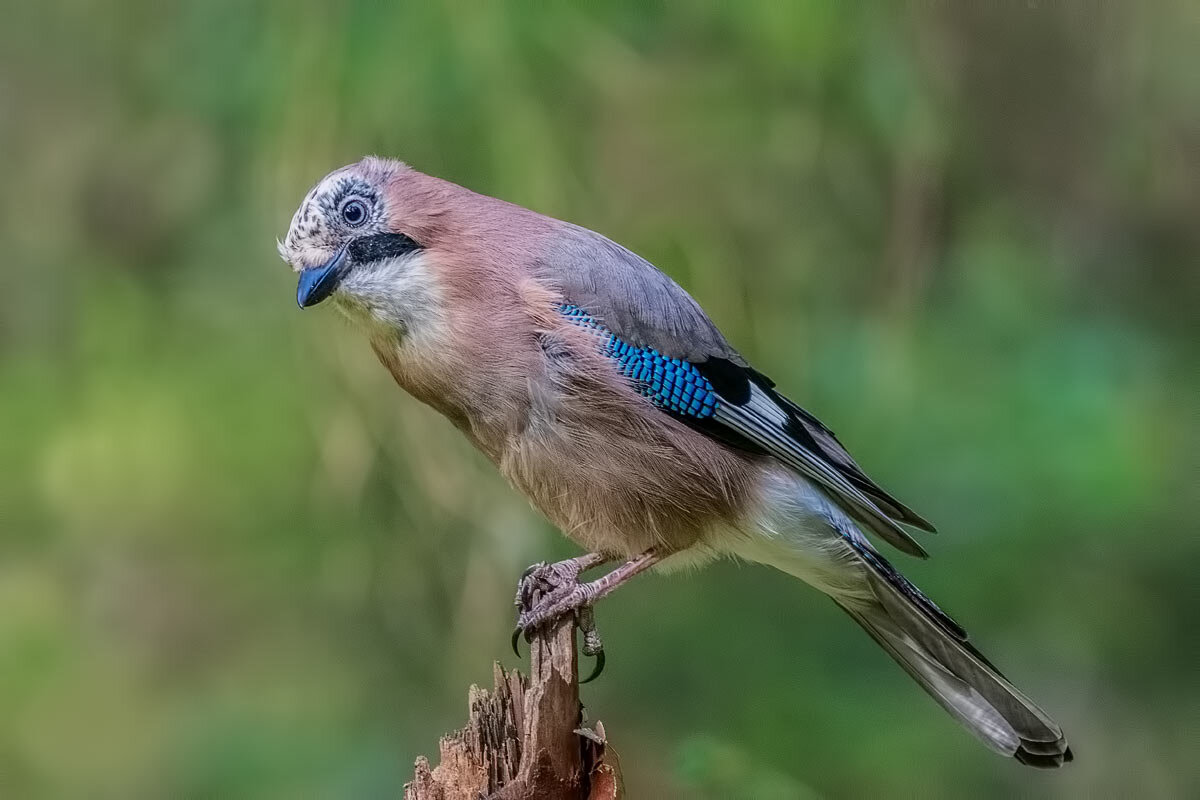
left=558, top=303, right=720, bottom=420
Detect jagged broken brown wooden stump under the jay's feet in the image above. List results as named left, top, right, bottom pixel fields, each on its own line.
left=404, top=616, right=622, bottom=800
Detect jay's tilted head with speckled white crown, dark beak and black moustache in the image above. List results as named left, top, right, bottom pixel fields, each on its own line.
left=278, top=157, right=438, bottom=329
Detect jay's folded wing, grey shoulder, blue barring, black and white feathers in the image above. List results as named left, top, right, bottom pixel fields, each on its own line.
left=535, top=225, right=934, bottom=557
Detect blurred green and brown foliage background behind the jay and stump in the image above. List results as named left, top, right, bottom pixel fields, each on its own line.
left=0, top=0, right=1200, bottom=798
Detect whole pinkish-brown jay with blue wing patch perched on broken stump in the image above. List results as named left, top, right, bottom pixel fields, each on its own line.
left=278, top=157, right=1072, bottom=766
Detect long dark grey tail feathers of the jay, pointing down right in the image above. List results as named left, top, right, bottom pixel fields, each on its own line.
left=834, top=559, right=1072, bottom=768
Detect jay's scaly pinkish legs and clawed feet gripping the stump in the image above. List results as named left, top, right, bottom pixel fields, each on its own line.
left=512, top=547, right=664, bottom=684
